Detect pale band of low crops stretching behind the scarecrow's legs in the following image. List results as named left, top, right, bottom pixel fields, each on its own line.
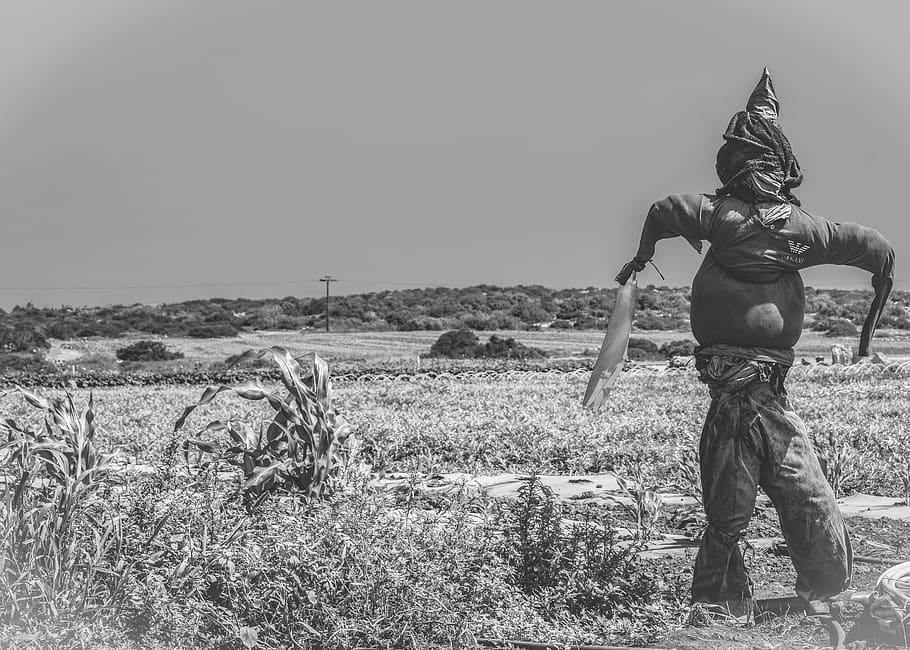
left=0, top=373, right=910, bottom=497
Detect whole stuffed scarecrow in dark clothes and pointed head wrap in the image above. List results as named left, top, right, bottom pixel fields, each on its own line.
left=616, top=68, right=894, bottom=615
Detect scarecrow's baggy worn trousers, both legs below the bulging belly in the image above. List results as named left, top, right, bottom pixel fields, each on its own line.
left=692, top=364, right=853, bottom=603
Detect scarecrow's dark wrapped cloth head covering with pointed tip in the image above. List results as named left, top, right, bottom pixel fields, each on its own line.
left=716, top=68, right=803, bottom=205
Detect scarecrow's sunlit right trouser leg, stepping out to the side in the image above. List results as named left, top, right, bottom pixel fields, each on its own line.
left=753, top=388, right=853, bottom=600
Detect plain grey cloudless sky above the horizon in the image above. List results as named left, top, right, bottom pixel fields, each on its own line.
left=0, top=0, right=910, bottom=309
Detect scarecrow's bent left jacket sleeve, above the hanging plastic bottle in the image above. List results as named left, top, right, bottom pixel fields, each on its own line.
left=635, top=194, right=714, bottom=262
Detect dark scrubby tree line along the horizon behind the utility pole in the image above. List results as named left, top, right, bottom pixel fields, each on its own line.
left=0, top=285, right=910, bottom=353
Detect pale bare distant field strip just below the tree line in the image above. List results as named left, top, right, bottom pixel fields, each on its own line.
left=48, top=330, right=910, bottom=366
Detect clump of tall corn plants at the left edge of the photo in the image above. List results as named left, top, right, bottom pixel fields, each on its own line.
left=0, top=388, right=124, bottom=621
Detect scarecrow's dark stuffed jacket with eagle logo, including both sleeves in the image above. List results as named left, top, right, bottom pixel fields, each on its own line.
left=636, top=194, right=894, bottom=364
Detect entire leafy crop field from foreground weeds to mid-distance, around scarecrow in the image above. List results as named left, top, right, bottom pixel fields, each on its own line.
left=0, top=350, right=910, bottom=649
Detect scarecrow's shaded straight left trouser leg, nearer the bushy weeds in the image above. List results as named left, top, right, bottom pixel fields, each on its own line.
left=692, top=394, right=761, bottom=603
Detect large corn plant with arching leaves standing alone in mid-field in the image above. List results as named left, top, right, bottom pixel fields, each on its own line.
left=174, top=347, right=350, bottom=507
